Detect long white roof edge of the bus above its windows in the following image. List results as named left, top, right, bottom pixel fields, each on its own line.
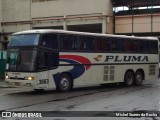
left=13, top=29, right=158, bottom=40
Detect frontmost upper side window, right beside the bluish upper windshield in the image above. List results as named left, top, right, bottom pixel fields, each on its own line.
left=41, top=34, right=58, bottom=49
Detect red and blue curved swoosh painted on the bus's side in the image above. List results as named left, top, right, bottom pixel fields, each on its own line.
left=53, top=55, right=91, bottom=83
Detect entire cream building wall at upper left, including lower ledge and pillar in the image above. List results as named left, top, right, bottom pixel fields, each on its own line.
left=2, top=0, right=113, bottom=33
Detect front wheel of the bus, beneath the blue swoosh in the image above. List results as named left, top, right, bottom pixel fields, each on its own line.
left=57, top=74, right=72, bottom=92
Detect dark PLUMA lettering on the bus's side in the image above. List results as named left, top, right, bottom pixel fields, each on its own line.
left=105, top=55, right=149, bottom=62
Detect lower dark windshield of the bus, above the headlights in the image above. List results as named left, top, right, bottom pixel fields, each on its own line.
left=6, top=49, right=37, bottom=72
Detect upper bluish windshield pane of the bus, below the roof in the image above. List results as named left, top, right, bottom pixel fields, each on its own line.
left=9, top=34, right=40, bottom=47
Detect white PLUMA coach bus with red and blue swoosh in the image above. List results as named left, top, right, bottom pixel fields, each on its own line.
left=5, top=30, right=159, bottom=92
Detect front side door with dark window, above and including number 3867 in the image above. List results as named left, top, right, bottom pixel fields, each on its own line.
left=37, top=50, right=59, bottom=89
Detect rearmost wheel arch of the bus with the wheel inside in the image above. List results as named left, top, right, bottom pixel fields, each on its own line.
left=134, top=69, right=145, bottom=86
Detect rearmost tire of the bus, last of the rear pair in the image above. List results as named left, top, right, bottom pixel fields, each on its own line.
left=134, top=71, right=144, bottom=86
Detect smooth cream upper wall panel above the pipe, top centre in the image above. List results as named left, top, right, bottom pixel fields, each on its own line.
left=31, top=0, right=112, bottom=18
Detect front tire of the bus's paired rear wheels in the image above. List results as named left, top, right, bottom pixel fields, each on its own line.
left=124, top=71, right=134, bottom=87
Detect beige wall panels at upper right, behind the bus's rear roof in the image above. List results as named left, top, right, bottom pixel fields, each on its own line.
left=115, top=14, right=160, bottom=34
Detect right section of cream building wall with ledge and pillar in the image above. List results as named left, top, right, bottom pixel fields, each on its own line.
left=31, top=0, right=113, bottom=33
